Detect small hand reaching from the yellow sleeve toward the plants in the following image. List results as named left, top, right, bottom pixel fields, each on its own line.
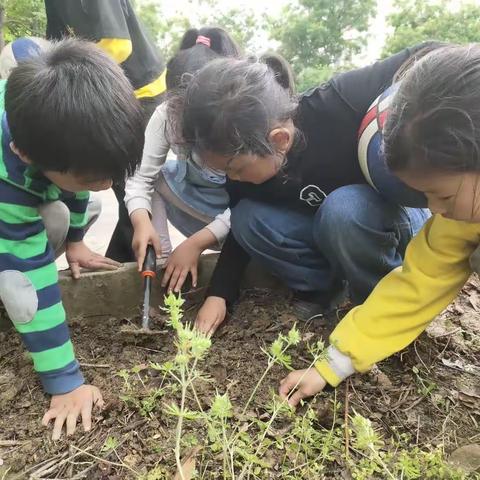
left=278, top=368, right=327, bottom=407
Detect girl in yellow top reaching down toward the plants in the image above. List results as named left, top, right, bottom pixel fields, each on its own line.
left=280, top=44, right=480, bottom=406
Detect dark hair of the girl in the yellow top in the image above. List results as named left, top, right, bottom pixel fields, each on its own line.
left=383, top=44, right=480, bottom=172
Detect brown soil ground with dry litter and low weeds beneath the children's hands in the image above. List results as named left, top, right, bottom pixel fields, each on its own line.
left=0, top=278, right=480, bottom=480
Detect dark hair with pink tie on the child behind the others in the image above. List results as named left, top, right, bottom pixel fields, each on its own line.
left=166, top=27, right=241, bottom=91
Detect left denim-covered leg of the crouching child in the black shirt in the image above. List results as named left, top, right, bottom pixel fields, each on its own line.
left=231, top=199, right=332, bottom=292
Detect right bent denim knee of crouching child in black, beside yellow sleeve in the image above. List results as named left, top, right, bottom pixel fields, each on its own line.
left=313, top=185, right=430, bottom=303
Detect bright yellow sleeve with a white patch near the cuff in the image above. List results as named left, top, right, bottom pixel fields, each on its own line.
left=316, top=216, right=480, bottom=386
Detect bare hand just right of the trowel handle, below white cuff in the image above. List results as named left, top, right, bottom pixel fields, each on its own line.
left=162, top=238, right=203, bottom=293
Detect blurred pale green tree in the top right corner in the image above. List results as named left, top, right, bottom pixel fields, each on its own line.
left=383, top=0, right=480, bottom=56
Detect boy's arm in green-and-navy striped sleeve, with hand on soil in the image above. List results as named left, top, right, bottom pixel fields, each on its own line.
left=0, top=188, right=101, bottom=438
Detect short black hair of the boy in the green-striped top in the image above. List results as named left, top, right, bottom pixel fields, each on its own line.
left=5, top=39, right=144, bottom=181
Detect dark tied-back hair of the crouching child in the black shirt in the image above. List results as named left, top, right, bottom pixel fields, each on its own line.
left=169, top=55, right=298, bottom=156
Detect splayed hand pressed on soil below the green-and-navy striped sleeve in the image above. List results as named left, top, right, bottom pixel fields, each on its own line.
left=42, top=385, right=103, bottom=440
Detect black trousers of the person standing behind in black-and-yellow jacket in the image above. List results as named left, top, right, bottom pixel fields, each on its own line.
left=106, top=95, right=163, bottom=263
